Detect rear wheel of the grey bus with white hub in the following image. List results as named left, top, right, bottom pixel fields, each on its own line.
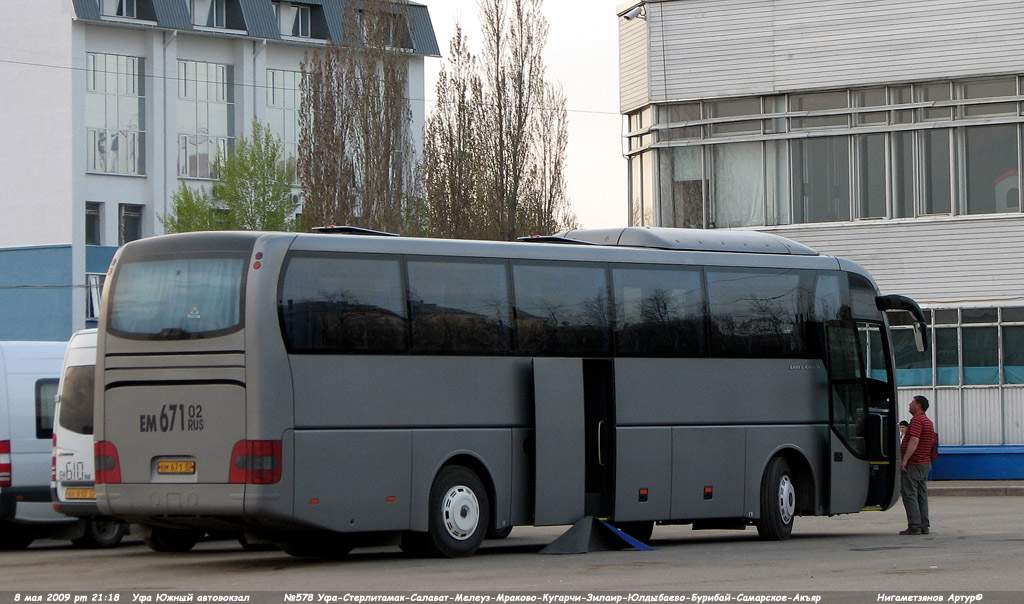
left=426, top=466, right=490, bottom=558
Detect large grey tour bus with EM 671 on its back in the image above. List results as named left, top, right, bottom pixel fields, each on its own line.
left=94, top=227, right=924, bottom=557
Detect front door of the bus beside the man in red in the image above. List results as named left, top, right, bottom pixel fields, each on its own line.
left=826, top=320, right=895, bottom=514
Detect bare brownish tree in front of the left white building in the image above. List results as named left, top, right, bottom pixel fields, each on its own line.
left=298, top=0, right=415, bottom=231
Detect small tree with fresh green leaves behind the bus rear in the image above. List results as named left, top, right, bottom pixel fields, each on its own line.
left=161, top=120, right=299, bottom=232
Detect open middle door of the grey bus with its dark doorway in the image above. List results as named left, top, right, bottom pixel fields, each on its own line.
left=534, top=358, right=614, bottom=526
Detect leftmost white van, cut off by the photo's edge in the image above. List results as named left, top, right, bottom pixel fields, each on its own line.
left=0, top=342, right=76, bottom=550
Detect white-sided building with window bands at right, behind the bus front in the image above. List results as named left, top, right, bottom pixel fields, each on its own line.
left=618, top=0, right=1024, bottom=478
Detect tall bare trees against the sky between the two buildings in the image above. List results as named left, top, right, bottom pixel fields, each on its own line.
left=424, top=0, right=575, bottom=240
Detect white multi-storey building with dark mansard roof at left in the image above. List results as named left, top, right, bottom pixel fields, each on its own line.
left=0, top=0, right=438, bottom=340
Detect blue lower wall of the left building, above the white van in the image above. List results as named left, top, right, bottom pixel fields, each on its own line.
left=0, top=246, right=73, bottom=341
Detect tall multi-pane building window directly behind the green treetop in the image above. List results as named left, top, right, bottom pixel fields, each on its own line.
left=177, top=59, right=234, bottom=178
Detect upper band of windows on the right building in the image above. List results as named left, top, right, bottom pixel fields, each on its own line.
left=638, top=75, right=1024, bottom=227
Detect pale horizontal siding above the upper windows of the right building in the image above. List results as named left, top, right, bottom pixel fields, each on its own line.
left=647, top=0, right=1024, bottom=101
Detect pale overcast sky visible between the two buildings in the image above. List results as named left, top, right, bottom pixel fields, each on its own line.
left=419, top=0, right=627, bottom=228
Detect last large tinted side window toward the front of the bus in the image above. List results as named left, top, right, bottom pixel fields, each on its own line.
left=708, top=268, right=814, bottom=357
